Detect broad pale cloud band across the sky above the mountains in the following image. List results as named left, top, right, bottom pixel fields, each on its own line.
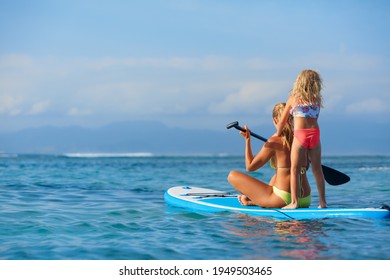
left=0, top=54, right=389, bottom=130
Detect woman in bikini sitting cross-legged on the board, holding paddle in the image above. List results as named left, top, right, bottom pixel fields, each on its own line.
left=228, top=103, right=311, bottom=208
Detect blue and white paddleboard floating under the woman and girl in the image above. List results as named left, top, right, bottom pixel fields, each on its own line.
left=164, top=186, right=390, bottom=220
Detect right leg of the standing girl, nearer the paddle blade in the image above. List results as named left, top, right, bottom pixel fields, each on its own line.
left=309, top=142, right=326, bottom=208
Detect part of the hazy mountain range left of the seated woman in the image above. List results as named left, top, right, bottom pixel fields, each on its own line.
left=0, top=122, right=247, bottom=154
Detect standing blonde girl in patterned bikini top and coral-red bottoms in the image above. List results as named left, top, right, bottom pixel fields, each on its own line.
left=275, top=70, right=326, bottom=209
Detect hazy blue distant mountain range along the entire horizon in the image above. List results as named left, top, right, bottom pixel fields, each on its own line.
left=0, top=118, right=390, bottom=155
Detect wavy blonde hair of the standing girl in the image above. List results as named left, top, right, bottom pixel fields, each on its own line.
left=291, top=70, right=322, bottom=107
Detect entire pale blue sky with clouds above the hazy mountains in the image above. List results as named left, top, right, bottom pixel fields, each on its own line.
left=0, top=0, right=390, bottom=153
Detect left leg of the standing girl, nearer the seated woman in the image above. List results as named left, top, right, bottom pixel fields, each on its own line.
left=283, top=138, right=306, bottom=209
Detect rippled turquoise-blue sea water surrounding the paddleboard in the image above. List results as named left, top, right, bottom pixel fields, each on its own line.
left=0, top=154, right=390, bottom=260
